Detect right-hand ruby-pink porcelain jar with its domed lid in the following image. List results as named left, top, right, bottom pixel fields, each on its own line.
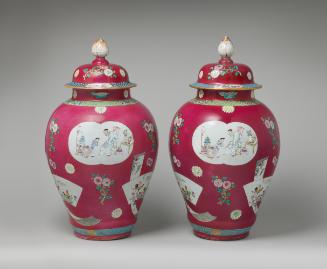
left=169, top=37, right=280, bottom=240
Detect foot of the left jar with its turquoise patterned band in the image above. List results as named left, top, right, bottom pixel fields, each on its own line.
left=73, top=225, right=133, bottom=241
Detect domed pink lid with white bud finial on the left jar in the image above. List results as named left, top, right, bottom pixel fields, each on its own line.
left=65, top=38, right=136, bottom=89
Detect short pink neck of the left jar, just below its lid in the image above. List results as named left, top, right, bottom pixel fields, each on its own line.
left=72, top=89, right=131, bottom=101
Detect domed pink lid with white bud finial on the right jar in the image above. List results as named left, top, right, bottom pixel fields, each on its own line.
left=190, top=36, right=261, bottom=91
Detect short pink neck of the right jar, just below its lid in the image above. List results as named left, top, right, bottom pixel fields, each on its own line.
left=196, top=89, right=255, bottom=101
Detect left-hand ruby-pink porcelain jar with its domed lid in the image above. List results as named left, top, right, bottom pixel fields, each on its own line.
left=45, top=39, right=158, bottom=240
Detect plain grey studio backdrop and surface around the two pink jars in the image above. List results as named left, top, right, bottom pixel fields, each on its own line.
left=0, top=0, right=327, bottom=268
